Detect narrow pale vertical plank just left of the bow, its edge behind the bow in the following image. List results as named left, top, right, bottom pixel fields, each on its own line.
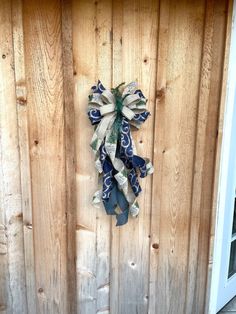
left=73, top=1, right=96, bottom=314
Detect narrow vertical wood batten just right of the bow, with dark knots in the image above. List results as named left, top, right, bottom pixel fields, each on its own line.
left=148, top=0, right=170, bottom=314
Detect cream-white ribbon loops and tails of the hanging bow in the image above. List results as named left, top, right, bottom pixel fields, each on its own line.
left=88, top=82, right=153, bottom=216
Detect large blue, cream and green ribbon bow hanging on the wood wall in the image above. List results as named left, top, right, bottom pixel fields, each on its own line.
left=88, top=81, right=153, bottom=226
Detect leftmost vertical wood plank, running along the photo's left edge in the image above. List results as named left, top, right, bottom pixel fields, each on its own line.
left=0, top=1, right=27, bottom=313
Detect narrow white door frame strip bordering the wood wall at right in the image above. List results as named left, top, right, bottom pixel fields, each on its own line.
left=209, top=0, right=236, bottom=314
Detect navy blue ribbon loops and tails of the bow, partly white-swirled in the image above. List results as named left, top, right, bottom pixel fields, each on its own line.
left=88, top=81, right=153, bottom=226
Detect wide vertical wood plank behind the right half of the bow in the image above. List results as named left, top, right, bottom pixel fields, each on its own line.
left=111, top=1, right=158, bottom=313
